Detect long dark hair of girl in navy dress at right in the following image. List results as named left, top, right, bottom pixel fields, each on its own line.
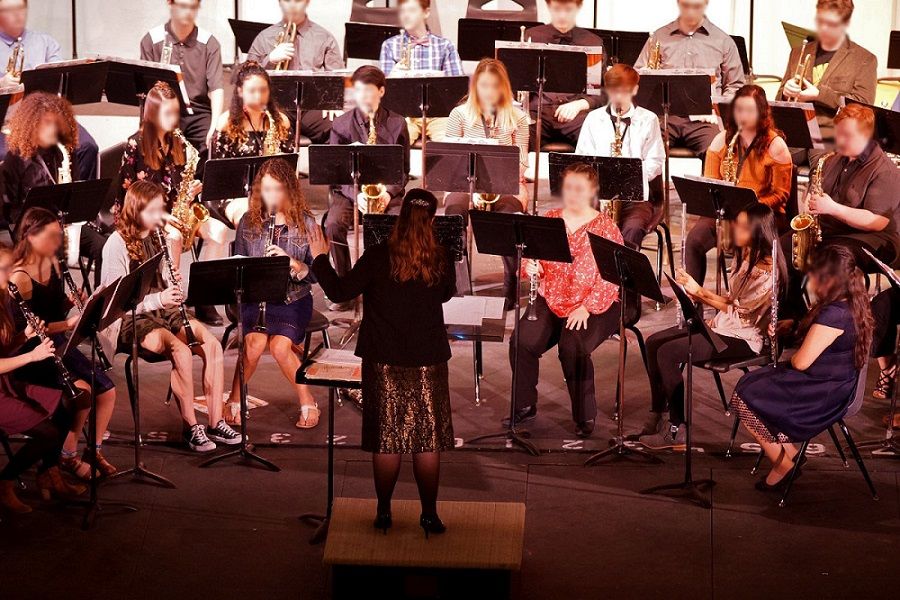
left=800, top=245, right=875, bottom=369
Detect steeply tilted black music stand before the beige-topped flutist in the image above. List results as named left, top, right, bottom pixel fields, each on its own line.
left=641, top=273, right=728, bottom=508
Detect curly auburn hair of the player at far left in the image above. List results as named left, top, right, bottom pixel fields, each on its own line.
left=6, top=92, right=78, bottom=158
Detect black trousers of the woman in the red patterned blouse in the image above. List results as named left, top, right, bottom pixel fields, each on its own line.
left=509, top=295, right=619, bottom=423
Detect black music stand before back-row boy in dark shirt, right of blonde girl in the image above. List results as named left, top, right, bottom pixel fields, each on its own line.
left=497, top=48, right=587, bottom=214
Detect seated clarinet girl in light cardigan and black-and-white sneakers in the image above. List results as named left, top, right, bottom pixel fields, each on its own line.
left=100, top=180, right=240, bottom=452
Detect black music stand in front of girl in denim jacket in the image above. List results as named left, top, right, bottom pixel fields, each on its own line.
left=192, top=256, right=291, bottom=471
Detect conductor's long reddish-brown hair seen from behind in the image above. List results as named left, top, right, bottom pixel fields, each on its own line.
left=388, top=188, right=447, bottom=286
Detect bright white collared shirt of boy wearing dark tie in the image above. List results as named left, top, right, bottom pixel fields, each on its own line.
left=575, top=105, right=666, bottom=200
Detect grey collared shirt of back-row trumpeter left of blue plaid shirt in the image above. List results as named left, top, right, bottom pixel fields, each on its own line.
left=247, top=18, right=344, bottom=71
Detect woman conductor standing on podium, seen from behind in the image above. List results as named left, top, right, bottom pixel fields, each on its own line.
left=310, top=189, right=456, bottom=536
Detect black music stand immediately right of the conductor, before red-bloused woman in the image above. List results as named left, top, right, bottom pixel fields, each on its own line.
left=469, top=210, right=572, bottom=456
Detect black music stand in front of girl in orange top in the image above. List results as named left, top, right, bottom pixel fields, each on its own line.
left=672, top=177, right=759, bottom=295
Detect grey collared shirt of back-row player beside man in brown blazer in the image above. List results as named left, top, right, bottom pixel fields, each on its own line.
left=634, top=18, right=744, bottom=98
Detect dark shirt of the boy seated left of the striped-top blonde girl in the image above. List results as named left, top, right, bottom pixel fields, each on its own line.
left=328, top=106, right=409, bottom=198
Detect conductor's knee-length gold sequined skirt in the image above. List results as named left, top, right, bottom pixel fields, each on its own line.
left=362, top=360, right=454, bottom=454
